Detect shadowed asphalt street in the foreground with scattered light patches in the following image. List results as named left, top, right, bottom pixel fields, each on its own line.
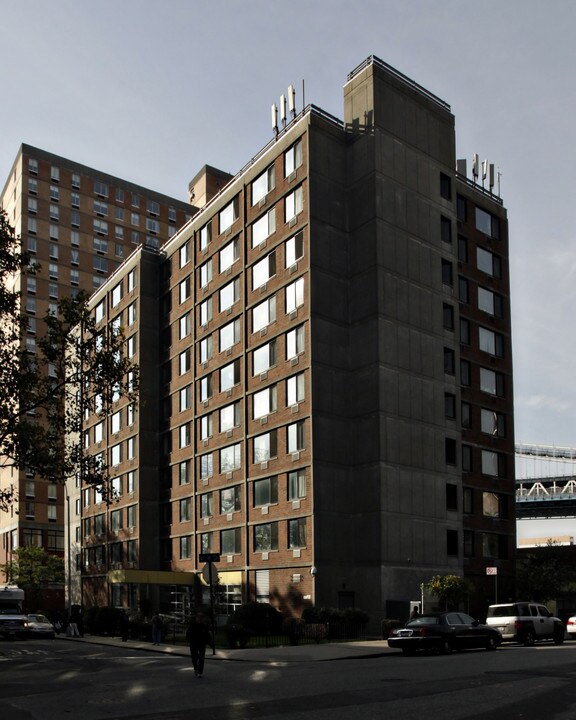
left=0, top=639, right=576, bottom=720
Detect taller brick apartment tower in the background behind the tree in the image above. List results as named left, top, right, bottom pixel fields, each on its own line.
left=0, top=145, right=194, bottom=596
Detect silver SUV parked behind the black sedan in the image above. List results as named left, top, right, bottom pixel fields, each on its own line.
left=486, top=602, right=564, bottom=645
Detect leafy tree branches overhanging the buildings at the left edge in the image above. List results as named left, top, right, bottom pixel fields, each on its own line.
left=0, top=211, right=138, bottom=510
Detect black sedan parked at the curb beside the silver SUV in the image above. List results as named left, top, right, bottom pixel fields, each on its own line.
left=388, top=612, right=502, bottom=655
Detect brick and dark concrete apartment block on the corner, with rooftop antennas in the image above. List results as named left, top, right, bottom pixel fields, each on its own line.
left=71, top=57, right=515, bottom=619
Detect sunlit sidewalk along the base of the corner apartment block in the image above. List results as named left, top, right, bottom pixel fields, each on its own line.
left=56, top=635, right=394, bottom=664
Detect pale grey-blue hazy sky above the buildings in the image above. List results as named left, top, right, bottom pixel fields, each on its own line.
left=0, top=0, right=576, bottom=447
